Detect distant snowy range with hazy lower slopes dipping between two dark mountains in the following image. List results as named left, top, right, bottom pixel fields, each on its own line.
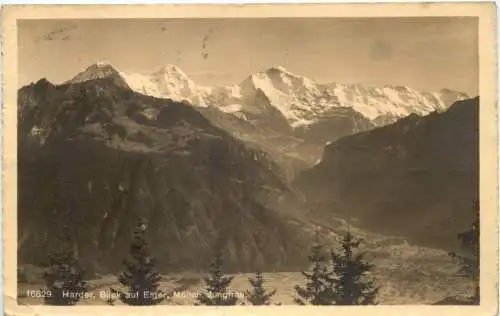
left=68, top=62, right=468, bottom=179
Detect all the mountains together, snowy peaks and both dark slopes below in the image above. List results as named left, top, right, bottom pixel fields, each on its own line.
left=18, top=63, right=478, bottom=272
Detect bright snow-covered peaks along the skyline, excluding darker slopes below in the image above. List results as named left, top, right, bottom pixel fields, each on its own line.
left=69, top=62, right=468, bottom=128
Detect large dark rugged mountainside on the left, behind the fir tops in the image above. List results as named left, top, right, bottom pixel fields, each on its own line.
left=18, top=79, right=316, bottom=271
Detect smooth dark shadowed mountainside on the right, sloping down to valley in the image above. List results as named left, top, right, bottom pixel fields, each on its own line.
left=294, top=98, right=479, bottom=249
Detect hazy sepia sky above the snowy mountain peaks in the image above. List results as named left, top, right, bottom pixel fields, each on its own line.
left=18, top=17, right=479, bottom=95
